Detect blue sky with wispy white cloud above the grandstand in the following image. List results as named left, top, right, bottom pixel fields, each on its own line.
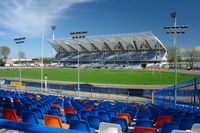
left=0, top=0, right=200, bottom=58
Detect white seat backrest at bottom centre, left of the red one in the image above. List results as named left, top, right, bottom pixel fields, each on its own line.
left=99, top=122, right=122, bottom=133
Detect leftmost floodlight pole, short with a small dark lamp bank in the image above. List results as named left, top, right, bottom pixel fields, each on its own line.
left=14, top=37, right=26, bottom=92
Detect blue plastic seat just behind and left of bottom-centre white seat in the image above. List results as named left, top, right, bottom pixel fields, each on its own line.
left=87, top=116, right=102, bottom=129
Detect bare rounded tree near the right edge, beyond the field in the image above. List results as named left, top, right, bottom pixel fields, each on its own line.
left=183, top=48, right=198, bottom=69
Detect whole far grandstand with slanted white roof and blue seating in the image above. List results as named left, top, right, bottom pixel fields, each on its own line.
left=48, top=32, right=167, bottom=69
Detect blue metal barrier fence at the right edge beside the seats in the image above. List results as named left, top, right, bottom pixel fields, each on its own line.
left=153, top=76, right=200, bottom=112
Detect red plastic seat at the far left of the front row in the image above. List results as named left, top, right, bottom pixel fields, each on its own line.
left=2, top=109, right=22, bottom=122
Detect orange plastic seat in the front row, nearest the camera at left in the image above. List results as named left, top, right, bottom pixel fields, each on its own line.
left=44, top=115, right=69, bottom=129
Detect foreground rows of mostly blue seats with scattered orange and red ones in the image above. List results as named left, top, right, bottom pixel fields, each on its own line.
left=0, top=90, right=199, bottom=133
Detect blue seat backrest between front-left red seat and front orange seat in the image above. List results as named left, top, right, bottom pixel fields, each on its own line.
left=22, top=111, right=39, bottom=124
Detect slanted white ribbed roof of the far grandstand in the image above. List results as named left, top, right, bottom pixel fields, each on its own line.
left=48, top=32, right=166, bottom=53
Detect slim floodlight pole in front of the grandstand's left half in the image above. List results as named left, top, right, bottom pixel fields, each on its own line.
left=70, top=31, right=88, bottom=98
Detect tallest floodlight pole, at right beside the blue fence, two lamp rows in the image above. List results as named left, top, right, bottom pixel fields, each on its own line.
left=164, top=12, right=188, bottom=104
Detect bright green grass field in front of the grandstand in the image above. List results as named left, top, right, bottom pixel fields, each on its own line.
left=0, top=68, right=198, bottom=85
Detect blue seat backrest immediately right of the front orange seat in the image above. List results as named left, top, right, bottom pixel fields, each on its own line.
left=69, top=120, right=90, bottom=132
